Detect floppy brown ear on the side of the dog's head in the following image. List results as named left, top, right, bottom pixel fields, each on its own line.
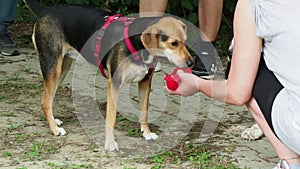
left=141, top=25, right=160, bottom=56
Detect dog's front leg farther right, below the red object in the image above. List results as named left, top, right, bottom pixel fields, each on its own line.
left=139, top=77, right=158, bottom=140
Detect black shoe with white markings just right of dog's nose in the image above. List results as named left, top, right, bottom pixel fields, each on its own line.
left=192, top=42, right=217, bottom=79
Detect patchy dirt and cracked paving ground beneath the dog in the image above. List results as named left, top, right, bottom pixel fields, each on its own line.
left=0, top=22, right=277, bottom=169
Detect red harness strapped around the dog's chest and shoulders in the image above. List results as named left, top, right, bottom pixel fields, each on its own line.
left=94, top=14, right=154, bottom=80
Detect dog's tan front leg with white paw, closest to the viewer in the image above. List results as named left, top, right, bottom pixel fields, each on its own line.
left=104, top=78, right=119, bottom=151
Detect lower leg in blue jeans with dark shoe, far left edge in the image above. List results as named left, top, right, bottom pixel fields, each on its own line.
left=0, top=0, right=19, bottom=56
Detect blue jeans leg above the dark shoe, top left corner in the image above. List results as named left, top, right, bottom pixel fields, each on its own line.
left=0, top=0, right=17, bottom=35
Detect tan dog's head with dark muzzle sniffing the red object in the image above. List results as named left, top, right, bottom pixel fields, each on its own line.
left=141, top=17, right=194, bottom=68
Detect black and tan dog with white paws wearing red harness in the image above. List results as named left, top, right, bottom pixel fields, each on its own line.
left=24, top=0, right=194, bottom=151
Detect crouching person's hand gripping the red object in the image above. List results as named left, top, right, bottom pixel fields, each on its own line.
left=166, top=70, right=199, bottom=96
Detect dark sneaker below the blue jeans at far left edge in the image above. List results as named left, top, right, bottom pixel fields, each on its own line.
left=0, top=33, right=20, bottom=56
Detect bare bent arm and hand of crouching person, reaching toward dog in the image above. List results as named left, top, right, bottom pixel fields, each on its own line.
left=168, top=0, right=262, bottom=105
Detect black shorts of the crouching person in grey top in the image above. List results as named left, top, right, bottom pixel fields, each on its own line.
left=252, top=57, right=283, bottom=133
